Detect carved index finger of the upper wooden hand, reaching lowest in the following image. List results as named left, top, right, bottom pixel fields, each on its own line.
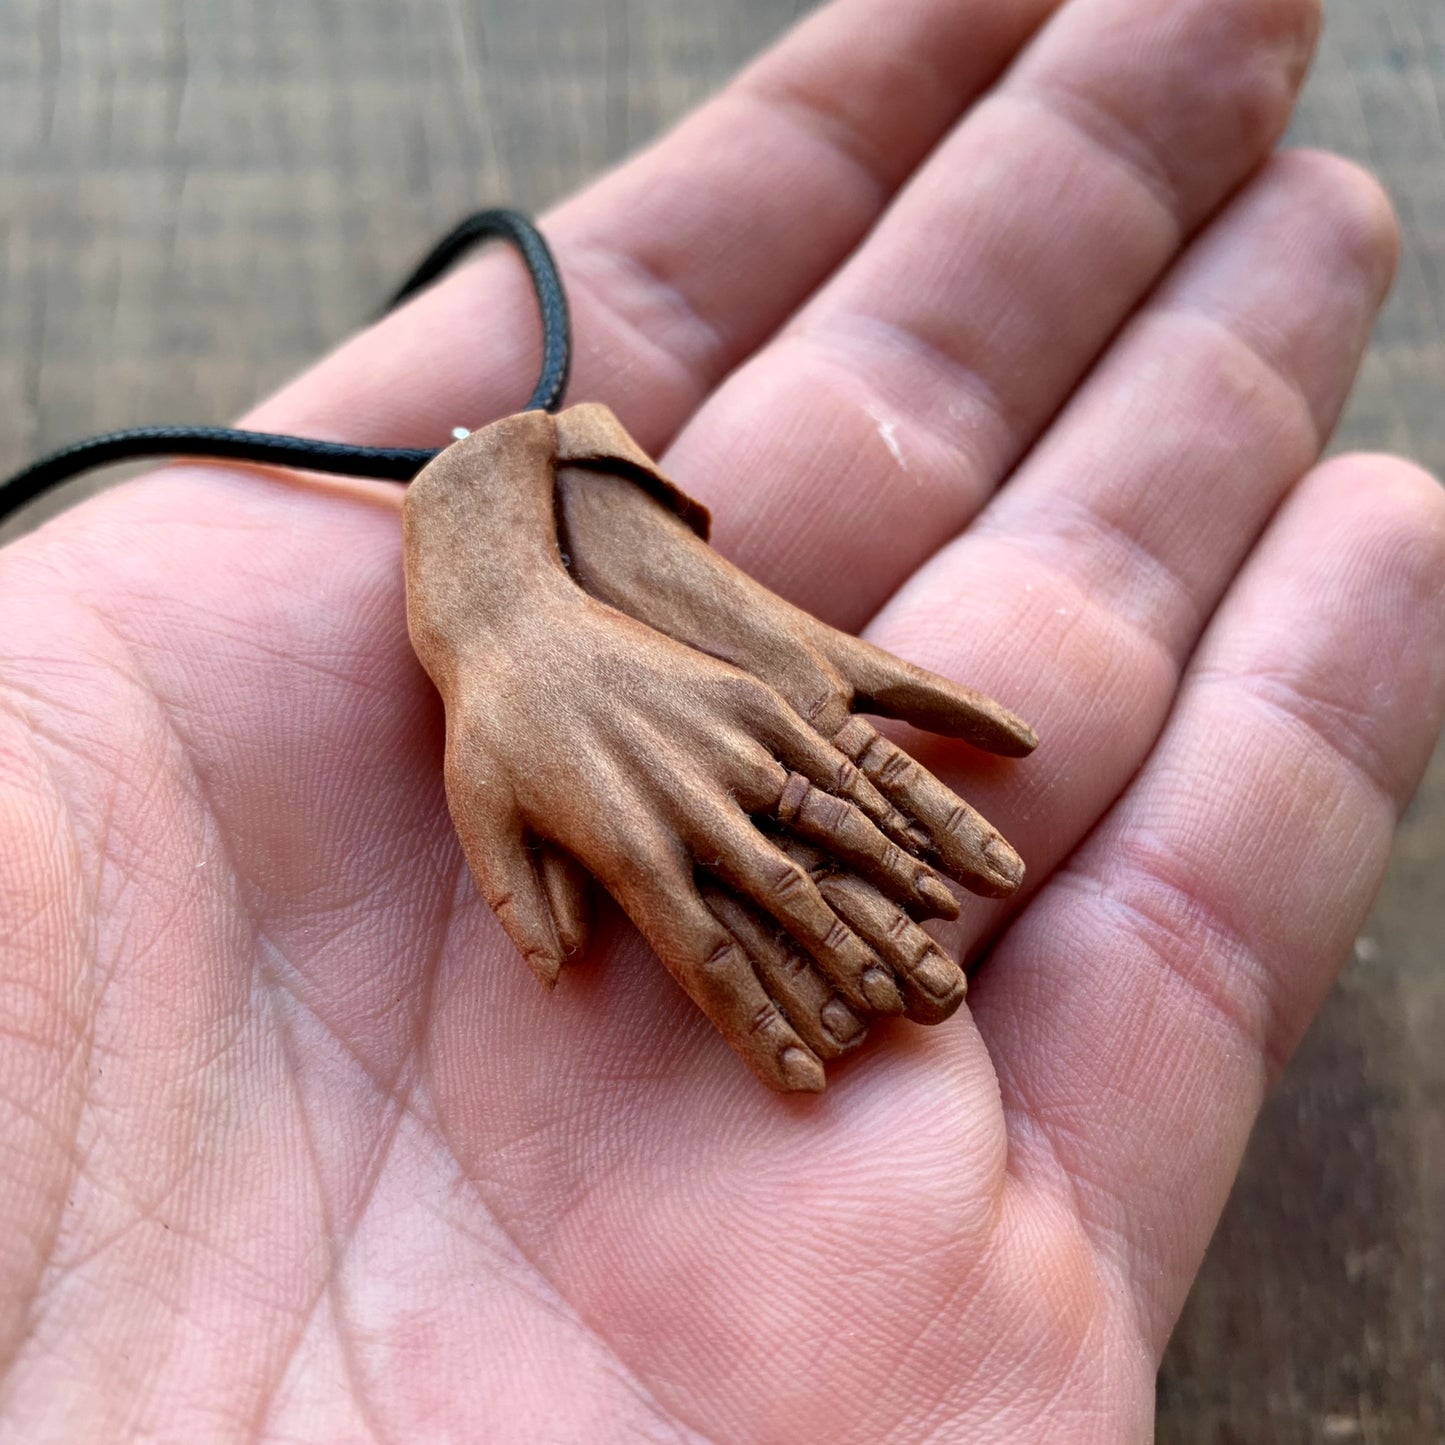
left=618, top=867, right=827, bottom=1094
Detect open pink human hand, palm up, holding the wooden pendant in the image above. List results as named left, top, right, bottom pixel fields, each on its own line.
left=0, top=0, right=1445, bottom=1445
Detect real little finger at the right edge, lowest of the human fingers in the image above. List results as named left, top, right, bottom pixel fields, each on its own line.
left=974, top=457, right=1445, bottom=1348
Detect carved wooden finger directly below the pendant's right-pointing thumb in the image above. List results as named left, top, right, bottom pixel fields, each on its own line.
left=834, top=717, right=1023, bottom=897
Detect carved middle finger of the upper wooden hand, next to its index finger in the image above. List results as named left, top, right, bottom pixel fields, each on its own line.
left=699, top=814, right=903, bottom=1013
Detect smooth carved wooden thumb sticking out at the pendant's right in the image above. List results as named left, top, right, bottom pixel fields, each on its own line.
left=827, top=629, right=1039, bottom=757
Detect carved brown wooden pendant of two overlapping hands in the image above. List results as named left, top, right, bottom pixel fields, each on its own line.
left=403, top=405, right=1038, bottom=1091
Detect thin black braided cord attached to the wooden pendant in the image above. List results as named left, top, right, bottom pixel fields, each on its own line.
left=0, top=210, right=572, bottom=522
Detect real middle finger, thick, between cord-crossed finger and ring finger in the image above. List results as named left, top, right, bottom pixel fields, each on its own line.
left=666, top=0, right=1318, bottom=621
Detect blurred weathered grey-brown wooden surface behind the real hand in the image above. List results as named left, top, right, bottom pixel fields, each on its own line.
left=0, top=0, right=1445, bottom=1445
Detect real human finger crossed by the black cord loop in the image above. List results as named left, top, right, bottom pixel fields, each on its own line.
left=249, top=0, right=1056, bottom=448
